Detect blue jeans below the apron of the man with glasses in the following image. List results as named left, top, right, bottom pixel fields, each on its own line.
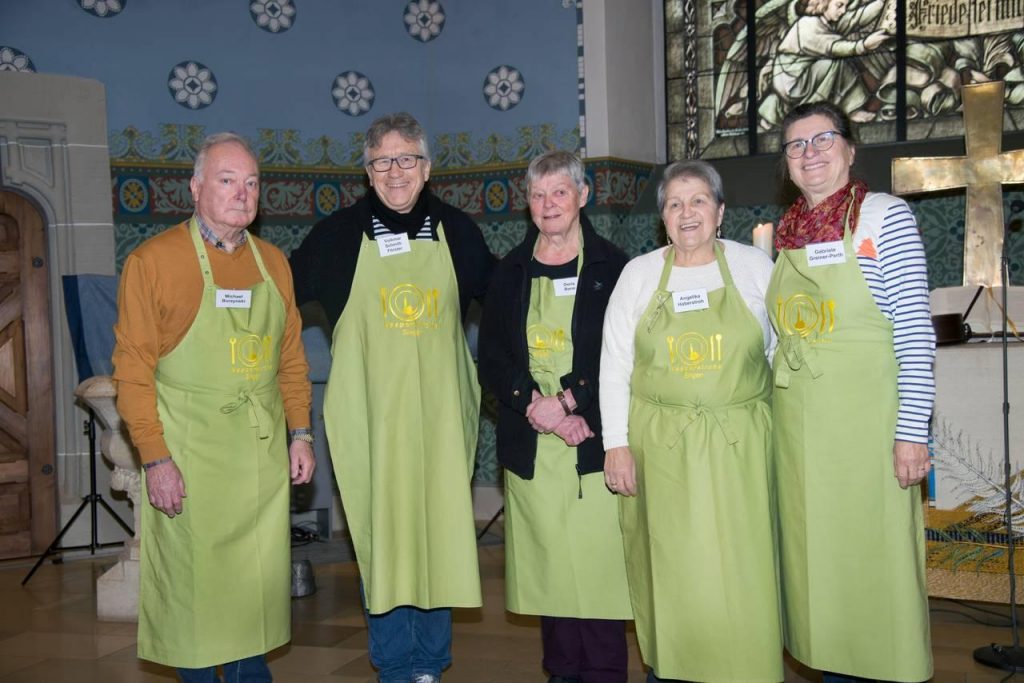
left=367, top=607, right=452, bottom=683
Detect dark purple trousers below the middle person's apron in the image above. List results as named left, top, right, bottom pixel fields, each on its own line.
left=541, top=616, right=629, bottom=683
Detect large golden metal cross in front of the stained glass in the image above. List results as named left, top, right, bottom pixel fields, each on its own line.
left=893, top=81, right=1024, bottom=287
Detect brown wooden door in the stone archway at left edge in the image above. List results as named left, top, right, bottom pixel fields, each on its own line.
left=0, top=191, right=57, bottom=558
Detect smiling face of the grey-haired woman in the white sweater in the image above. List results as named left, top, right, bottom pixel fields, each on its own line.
left=662, top=176, right=725, bottom=265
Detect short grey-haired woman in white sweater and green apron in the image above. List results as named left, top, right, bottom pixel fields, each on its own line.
left=600, top=161, right=782, bottom=682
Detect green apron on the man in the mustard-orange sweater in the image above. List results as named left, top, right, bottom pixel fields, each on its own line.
left=138, top=218, right=291, bottom=669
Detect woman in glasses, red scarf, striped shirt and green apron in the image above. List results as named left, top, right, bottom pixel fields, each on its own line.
left=766, top=102, right=935, bottom=683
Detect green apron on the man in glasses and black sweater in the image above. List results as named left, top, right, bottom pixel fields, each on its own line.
left=324, top=225, right=481, bottom=614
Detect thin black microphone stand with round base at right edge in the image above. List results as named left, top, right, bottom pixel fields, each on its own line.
left=974, top=220, right=1024, bottom=673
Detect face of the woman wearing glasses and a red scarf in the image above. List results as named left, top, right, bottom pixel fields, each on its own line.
left=785, top=114, right=856, bottom=207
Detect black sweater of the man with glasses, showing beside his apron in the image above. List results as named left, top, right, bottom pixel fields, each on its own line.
left=289, top=189, right=496, bottom=330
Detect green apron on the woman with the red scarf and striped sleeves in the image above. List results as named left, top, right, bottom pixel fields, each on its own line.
left=766, top=219, right=932, bottom=681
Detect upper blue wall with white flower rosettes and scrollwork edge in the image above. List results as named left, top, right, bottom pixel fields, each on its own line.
left=0, top=0, right=583, bottom=167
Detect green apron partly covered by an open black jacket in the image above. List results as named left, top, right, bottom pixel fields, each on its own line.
left=505, top=251, right=633, bottom=620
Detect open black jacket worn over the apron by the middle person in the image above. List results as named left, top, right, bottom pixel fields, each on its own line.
left=479, top=214, right=629, bottom=479
